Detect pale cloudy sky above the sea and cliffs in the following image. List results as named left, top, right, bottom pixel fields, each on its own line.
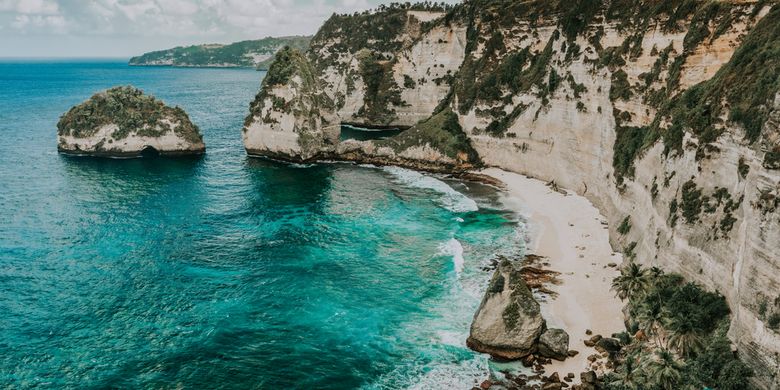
left=0, top=0, right=456, bottom=58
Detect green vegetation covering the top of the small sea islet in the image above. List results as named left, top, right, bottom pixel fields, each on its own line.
left=57, top=86, right=203, bottom=142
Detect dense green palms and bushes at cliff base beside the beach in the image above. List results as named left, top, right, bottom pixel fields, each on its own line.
left=605, top=262, right=753, bottom=390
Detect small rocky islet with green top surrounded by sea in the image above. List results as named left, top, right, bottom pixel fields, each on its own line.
left=57, top=86, right=206, bottom=157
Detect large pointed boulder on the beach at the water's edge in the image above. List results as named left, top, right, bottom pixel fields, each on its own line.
left=467, top=260, right=545, bottom=360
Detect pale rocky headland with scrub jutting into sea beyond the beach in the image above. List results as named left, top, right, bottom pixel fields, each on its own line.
left=243, top=6, right=477, bottom=171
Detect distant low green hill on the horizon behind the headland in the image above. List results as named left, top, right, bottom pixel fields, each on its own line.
left=130, top=36, right=311, bottom=70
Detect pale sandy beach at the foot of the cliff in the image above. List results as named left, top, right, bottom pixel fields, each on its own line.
left=479, top=168, right=625, bottom=382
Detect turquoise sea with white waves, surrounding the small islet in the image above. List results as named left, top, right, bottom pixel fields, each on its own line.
left=0, top=61, right=523, bottom=389
